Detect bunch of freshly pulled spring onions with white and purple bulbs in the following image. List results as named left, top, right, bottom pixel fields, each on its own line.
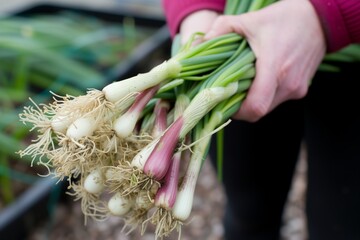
left=19, top=0, right=360, bottom=238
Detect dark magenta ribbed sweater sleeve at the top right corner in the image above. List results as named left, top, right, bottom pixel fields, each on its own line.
left=310, top=0, right=360, bottom=52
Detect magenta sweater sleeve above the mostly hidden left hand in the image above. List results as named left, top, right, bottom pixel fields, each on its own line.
left=162, top=0, right=225, bottom=37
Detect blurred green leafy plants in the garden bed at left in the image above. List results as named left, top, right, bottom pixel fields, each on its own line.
left=0, top=11, right=154, bottom=207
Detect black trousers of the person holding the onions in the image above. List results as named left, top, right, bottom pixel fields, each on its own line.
left=210, top=64, right=360, bottom=240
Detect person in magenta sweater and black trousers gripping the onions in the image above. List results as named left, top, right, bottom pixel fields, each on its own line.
left=163, top=0, right=360, bottom=240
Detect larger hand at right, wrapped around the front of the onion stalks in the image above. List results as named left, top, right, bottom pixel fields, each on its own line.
left=205, top=0, right=326, bottom=122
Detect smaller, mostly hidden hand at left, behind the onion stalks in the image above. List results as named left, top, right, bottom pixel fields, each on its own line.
left=179, top=10, right=219, bottom=45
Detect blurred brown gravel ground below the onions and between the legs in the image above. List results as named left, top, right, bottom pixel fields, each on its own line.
left=29, top=147, right=306, bottom=240
